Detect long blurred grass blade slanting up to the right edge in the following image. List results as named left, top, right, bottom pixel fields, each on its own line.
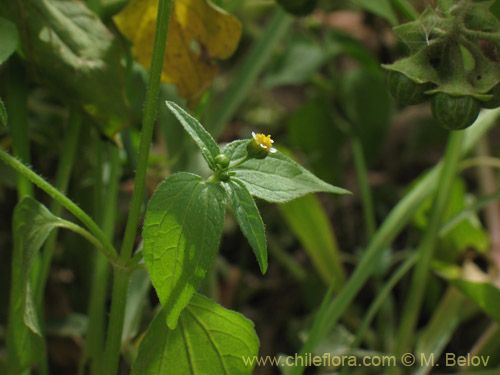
left=291, top=109, right=500, bottom=375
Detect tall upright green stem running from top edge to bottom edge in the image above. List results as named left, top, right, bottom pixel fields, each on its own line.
left=101, top=0, right=173, bottom=375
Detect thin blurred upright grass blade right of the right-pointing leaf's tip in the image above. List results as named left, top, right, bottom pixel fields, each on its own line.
left=351, top=136, right=376, bottom=242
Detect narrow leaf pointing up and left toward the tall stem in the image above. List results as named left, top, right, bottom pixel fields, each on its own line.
left=166, top=101, right=220, bottom=169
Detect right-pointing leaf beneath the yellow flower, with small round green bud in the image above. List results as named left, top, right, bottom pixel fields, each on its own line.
left=224, top=140, right=349, bottom=203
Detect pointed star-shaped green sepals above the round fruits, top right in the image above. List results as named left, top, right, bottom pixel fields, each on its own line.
left=383, top=1, right=500, bottom=101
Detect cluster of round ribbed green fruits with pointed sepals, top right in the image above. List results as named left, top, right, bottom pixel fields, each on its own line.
left=384, top=0, right=500, bottom=130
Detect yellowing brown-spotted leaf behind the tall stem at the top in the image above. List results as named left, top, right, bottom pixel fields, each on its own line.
left=114, top=0, right=241, bottom=106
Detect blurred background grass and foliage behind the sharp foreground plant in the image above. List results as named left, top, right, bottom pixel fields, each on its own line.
left=0, top=0, right=500, bottom=375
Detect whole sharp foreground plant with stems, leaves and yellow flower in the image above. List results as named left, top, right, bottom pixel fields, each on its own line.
left=0, top=1, right=346, bottom=374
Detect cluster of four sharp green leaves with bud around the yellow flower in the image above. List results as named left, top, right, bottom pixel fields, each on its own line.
left=143, top=102, right=347, bottom=329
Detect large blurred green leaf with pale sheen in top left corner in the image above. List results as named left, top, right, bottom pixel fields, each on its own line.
left=0, top=0, right=130, bottom=138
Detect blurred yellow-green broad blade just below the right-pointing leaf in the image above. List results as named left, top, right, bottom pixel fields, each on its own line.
left=279, top=195, right=345, bottom=290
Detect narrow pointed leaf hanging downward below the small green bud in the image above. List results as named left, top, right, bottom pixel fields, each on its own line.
left=222, top=177, right=267, bottom=274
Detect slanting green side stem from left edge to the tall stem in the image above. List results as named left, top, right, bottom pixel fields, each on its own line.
left=0, top=148, right=118, bottom=262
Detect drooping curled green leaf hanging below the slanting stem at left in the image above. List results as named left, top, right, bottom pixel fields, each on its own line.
left=7, top=197, right=67, bottom=373
